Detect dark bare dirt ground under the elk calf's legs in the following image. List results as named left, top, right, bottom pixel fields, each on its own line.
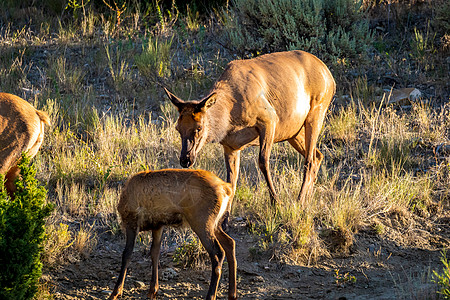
left=43, top=207, right=450, bottom=300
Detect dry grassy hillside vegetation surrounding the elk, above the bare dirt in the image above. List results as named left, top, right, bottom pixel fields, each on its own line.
left=0, top=1, right=450, bottom=297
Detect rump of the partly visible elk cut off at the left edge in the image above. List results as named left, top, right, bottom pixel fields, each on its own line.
left=0, top=93, right=50, bottom=197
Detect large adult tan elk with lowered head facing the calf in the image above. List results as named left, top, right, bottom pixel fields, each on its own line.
left=165, top=51, right=336, bottom=205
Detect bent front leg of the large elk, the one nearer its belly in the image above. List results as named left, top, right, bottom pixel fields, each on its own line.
left=259, top=122, right=278, bottom=205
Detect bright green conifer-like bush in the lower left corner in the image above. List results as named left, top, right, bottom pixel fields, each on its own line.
left=0, top=155, right=52, bottom=300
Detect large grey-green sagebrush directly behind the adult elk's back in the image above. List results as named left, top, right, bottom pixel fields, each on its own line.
left=224, top=0, right=372, bottom=63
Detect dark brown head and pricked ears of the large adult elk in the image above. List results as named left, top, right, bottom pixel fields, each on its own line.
left=164, top=88, right=216, bottom=168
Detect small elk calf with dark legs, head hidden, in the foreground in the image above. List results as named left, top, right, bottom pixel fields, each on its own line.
left=110, top=169, right=237, bottom=299
